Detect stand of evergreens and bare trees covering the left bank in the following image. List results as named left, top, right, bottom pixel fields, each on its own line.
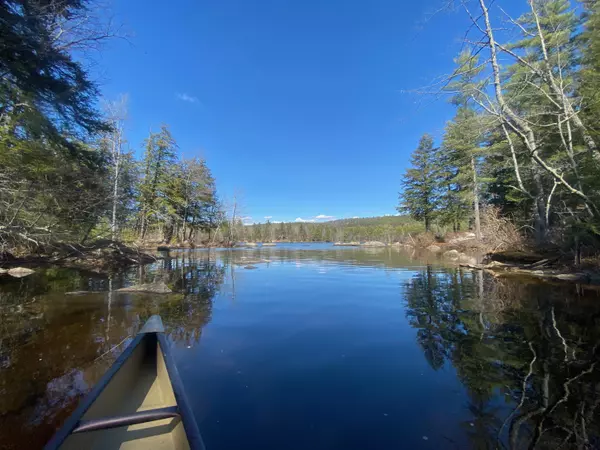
left=0, top=0, right=223, bottom=252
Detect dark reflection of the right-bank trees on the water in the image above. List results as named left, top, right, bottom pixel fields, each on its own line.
left=405, top=266, right=600, bottom=449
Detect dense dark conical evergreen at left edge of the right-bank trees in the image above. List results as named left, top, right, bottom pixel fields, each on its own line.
left=397, top=134, right=439, bottom=231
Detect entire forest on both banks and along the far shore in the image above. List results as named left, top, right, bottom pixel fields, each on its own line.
left=0, top=0, right=600, bottom=259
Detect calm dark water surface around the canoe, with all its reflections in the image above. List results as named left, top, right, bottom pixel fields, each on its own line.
left=0, top=245, right=600, bottom=450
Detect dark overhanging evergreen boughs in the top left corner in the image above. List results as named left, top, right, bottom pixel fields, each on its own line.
left=0, top=0, right=107, bottom=152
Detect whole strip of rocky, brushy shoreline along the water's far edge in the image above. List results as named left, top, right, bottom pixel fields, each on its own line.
left=0, top=239, right=600, bottom=286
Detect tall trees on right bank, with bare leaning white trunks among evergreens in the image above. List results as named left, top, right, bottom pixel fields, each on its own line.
left=398, top=0, right=600, bottom=259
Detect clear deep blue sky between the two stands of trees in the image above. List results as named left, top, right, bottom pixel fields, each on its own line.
left=95, top=0, right=514, bottom=222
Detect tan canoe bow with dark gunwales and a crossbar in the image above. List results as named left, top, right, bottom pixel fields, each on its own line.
left=45, top=316, right=204, bottom=450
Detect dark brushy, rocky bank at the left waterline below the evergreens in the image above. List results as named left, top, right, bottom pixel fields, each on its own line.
left=0, top=240, right=157, bottom=272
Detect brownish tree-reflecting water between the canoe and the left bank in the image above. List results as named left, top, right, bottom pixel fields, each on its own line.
left=0, top=253, right=226, bottom=448
